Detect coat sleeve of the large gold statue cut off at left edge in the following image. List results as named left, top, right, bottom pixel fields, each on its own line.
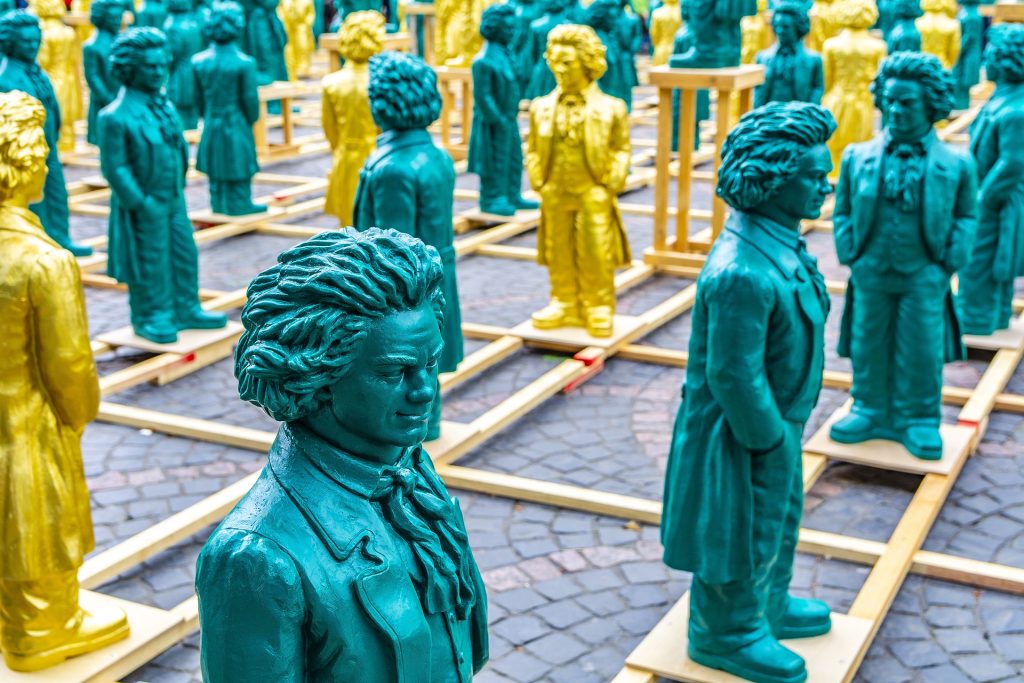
left=29, top=250, right=99, bottom=430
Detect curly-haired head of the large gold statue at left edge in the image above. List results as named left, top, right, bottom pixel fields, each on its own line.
left=0, top=90, right=50, bottom=205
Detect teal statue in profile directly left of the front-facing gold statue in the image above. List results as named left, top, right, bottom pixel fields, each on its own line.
left=469, top=4, right=538, bottom=216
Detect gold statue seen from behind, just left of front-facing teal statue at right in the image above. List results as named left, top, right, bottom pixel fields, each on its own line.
left=821, top=0, right=886, bottom=179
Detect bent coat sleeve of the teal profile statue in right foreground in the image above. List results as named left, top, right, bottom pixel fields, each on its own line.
left=703, top=265, right=785, bottom=451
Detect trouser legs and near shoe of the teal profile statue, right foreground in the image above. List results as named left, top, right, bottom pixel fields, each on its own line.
left=688, top=422, right=806, bottom=683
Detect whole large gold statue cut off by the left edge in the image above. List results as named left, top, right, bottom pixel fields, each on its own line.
left=0, top=91, right=128, bottom=678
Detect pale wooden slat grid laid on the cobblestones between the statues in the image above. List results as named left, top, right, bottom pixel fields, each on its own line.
left=25, top=49, right=1024, bottom=683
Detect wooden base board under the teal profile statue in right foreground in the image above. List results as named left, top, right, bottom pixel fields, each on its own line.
left=626, top=592, right=871, bottom=683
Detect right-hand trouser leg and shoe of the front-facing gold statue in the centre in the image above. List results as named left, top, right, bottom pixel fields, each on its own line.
left=573, top=185, right=616, bottom=337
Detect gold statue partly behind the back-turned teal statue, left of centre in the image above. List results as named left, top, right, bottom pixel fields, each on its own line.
left=321, top=10, right=384, bottom=227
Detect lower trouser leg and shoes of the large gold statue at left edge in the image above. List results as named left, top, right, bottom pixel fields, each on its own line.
left=0, top=571, right=128, bottom=672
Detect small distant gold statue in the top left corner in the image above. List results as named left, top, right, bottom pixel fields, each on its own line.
left=31, top=0, right=83, bottom=152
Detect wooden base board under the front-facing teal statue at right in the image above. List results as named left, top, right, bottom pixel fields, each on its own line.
left=804, top=407, right=976, bottom=474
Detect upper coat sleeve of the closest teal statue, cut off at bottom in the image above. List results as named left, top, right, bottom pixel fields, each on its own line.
left=196, top=528, right=306, bottom=683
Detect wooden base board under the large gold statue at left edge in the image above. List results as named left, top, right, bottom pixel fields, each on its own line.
left=0, top=591, right=181, bottom=683
